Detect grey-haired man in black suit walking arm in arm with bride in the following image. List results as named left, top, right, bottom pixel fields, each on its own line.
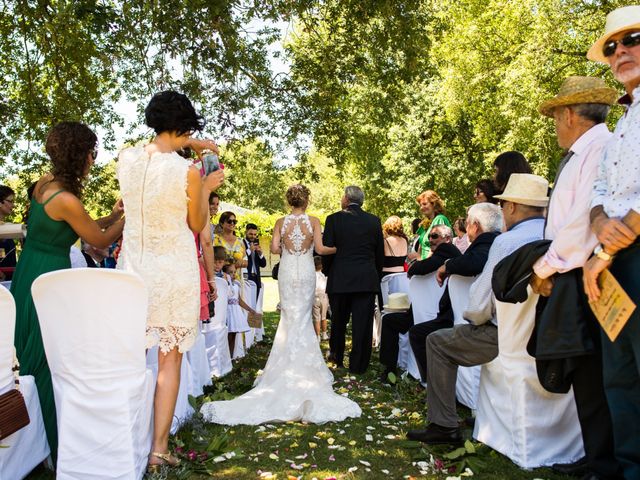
left=322, top=186, right=384, bottom=373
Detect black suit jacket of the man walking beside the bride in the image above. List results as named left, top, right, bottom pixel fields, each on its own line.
left=322, top=204, right=384, bottom=294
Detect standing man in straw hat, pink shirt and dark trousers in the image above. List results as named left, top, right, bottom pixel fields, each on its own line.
left=531, top=77, right=620, bottom=478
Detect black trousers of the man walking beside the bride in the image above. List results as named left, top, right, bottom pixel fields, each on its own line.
left=329, top=292, right=376, bottom=373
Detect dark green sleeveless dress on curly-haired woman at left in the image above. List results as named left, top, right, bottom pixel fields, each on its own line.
left=11, top=190, right=78, bottom=463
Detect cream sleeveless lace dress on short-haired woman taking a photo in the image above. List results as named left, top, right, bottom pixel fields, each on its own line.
left=116, top=147, right=200, bottom=353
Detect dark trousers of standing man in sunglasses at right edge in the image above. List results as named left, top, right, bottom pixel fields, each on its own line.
left=602, top=243, right=640, bottom=479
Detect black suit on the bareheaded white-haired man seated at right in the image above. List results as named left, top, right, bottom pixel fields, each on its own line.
left=409, top=232, right=500, bottom=381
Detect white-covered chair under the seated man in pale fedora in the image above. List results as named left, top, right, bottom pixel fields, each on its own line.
left=473, top=289, right=584, bottom=468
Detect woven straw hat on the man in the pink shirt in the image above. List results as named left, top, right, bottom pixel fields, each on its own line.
left=538, top=77, right=618, bottom=117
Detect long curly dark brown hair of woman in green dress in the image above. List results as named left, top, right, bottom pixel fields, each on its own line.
left=45, top=122, right=98, bottom=198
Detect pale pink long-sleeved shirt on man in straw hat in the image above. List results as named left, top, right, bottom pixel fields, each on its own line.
left=533, top=123, right=611, bottom=278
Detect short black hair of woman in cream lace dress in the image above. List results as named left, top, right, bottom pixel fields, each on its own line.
left=144, top=90, right=206, bottom=135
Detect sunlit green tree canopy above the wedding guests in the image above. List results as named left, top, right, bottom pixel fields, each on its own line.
left=0, top=0, right=625, bottom=225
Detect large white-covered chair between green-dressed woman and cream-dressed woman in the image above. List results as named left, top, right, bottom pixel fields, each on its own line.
left=31, top=268, right=155, bottom=480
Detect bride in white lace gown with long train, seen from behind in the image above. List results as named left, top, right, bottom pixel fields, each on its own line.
left=200, top=185, right=362, bottom=425
